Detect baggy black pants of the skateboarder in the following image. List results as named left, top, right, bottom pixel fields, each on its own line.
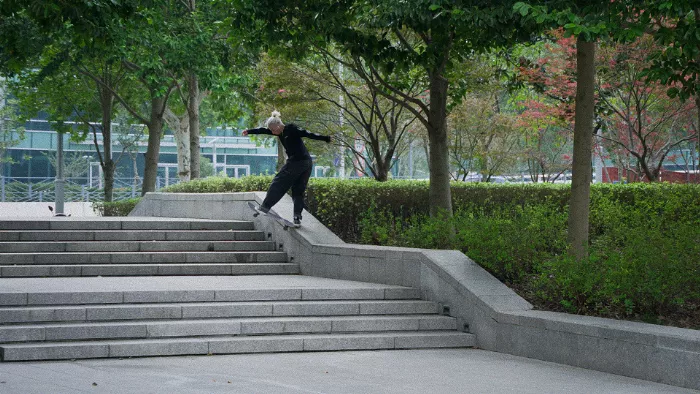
left=262, top=160, right=312, bottom=217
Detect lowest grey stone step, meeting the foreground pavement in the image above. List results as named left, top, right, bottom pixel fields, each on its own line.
left=0, top=331, right=475, bottom=361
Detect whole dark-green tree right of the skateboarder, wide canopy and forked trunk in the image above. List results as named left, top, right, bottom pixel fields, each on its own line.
left=230, top=0, right=528, bottom=216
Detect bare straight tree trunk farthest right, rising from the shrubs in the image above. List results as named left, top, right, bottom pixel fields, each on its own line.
left=568, top=36, right=595, bottom=260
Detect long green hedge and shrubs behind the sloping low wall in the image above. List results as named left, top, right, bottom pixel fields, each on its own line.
left=160, top=177, right=700, bottom=328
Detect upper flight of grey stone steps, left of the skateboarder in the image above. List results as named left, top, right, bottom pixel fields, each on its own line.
left=0, top=218, right=299, bottom=277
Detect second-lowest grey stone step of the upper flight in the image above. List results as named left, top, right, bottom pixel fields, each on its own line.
left=0, top=251, right=287, bottom=266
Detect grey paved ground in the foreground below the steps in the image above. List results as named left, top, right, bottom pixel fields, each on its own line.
left=0, top=349, right=697, bottom=394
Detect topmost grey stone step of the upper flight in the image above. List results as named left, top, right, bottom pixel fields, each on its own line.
left=0, top=217, right=254, bottom=231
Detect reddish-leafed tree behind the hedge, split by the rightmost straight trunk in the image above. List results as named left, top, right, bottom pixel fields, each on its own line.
left=519, top=30, right=697, bottom=182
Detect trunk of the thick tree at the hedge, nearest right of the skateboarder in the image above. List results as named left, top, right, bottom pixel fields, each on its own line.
left=428, top=73, right=452, bottom=217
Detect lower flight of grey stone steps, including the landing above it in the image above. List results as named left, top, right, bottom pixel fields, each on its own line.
left=0, top=275, right=474, bottom=361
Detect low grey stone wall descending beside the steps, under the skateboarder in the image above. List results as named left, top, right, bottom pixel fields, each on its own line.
left=130, top=193, right=700, bottom=389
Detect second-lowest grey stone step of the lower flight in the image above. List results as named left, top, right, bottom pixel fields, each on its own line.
left=0, top=315, right=457, bottom=343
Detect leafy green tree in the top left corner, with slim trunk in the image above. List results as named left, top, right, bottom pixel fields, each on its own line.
left=0, top=0, right=133, bottom=201
